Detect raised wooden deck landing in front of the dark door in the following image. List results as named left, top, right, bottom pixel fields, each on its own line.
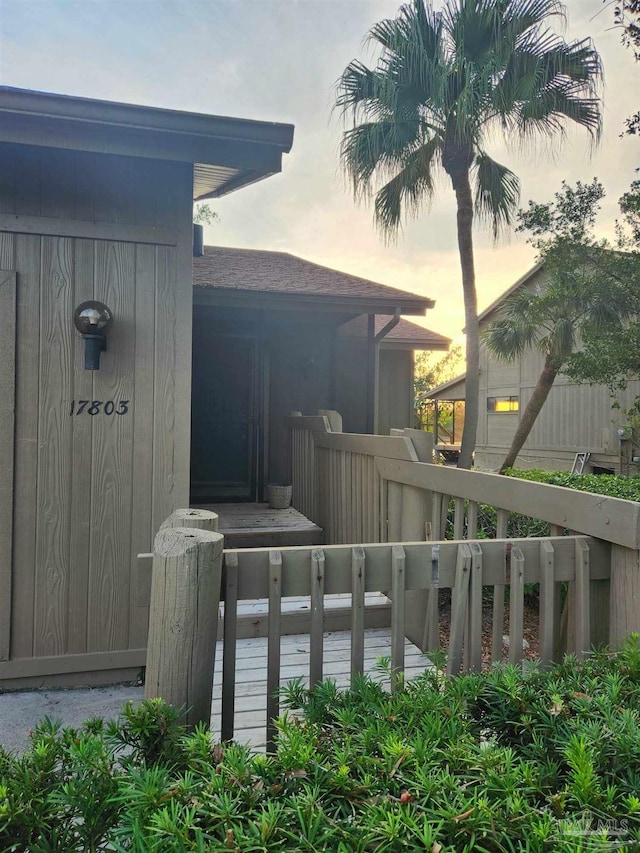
left=198, top=503, right=324, bottom=548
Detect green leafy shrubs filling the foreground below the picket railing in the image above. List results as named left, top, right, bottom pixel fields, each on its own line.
left=0, top=637, right=640, bottom=853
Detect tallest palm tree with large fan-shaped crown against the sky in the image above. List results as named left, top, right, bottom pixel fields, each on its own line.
left=336, top=0, right=601, bottom=468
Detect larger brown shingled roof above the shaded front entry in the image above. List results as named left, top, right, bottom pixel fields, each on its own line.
left=193, top=246, right=435, bottom=314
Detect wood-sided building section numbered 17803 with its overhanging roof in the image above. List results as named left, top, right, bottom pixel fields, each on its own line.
left=0, top=88, right=293, bottom=687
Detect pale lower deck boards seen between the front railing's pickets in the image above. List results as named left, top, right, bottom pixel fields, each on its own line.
left=211, top=628, right=431, bottom=751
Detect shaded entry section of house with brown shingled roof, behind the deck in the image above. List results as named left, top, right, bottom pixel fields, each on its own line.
left=191, top=246, right=450, bottom=502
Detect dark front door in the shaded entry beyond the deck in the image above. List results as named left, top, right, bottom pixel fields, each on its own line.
left=191, top=322, right=258, bottom=503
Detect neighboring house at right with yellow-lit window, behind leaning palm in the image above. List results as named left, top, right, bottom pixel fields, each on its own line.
left=429, top=265, right=640, bottom=474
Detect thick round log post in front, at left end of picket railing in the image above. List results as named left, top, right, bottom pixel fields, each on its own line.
left=144, top=527, right=224, bottom=727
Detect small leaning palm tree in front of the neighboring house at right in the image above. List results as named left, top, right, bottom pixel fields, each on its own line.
left=482, top=270, right=633, bottom=474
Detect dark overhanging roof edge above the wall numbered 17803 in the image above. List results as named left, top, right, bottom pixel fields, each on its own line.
left=0, top=86, right=293, bottom=199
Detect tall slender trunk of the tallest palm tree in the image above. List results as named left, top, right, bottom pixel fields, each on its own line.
left=451, top=168, right=480, bottom=468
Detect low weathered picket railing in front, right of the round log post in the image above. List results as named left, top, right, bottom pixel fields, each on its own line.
left=222, top=536, right=609, bottom=743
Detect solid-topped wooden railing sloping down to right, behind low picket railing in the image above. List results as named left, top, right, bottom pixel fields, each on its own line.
left=293, top=418, right=640, bottom=649
